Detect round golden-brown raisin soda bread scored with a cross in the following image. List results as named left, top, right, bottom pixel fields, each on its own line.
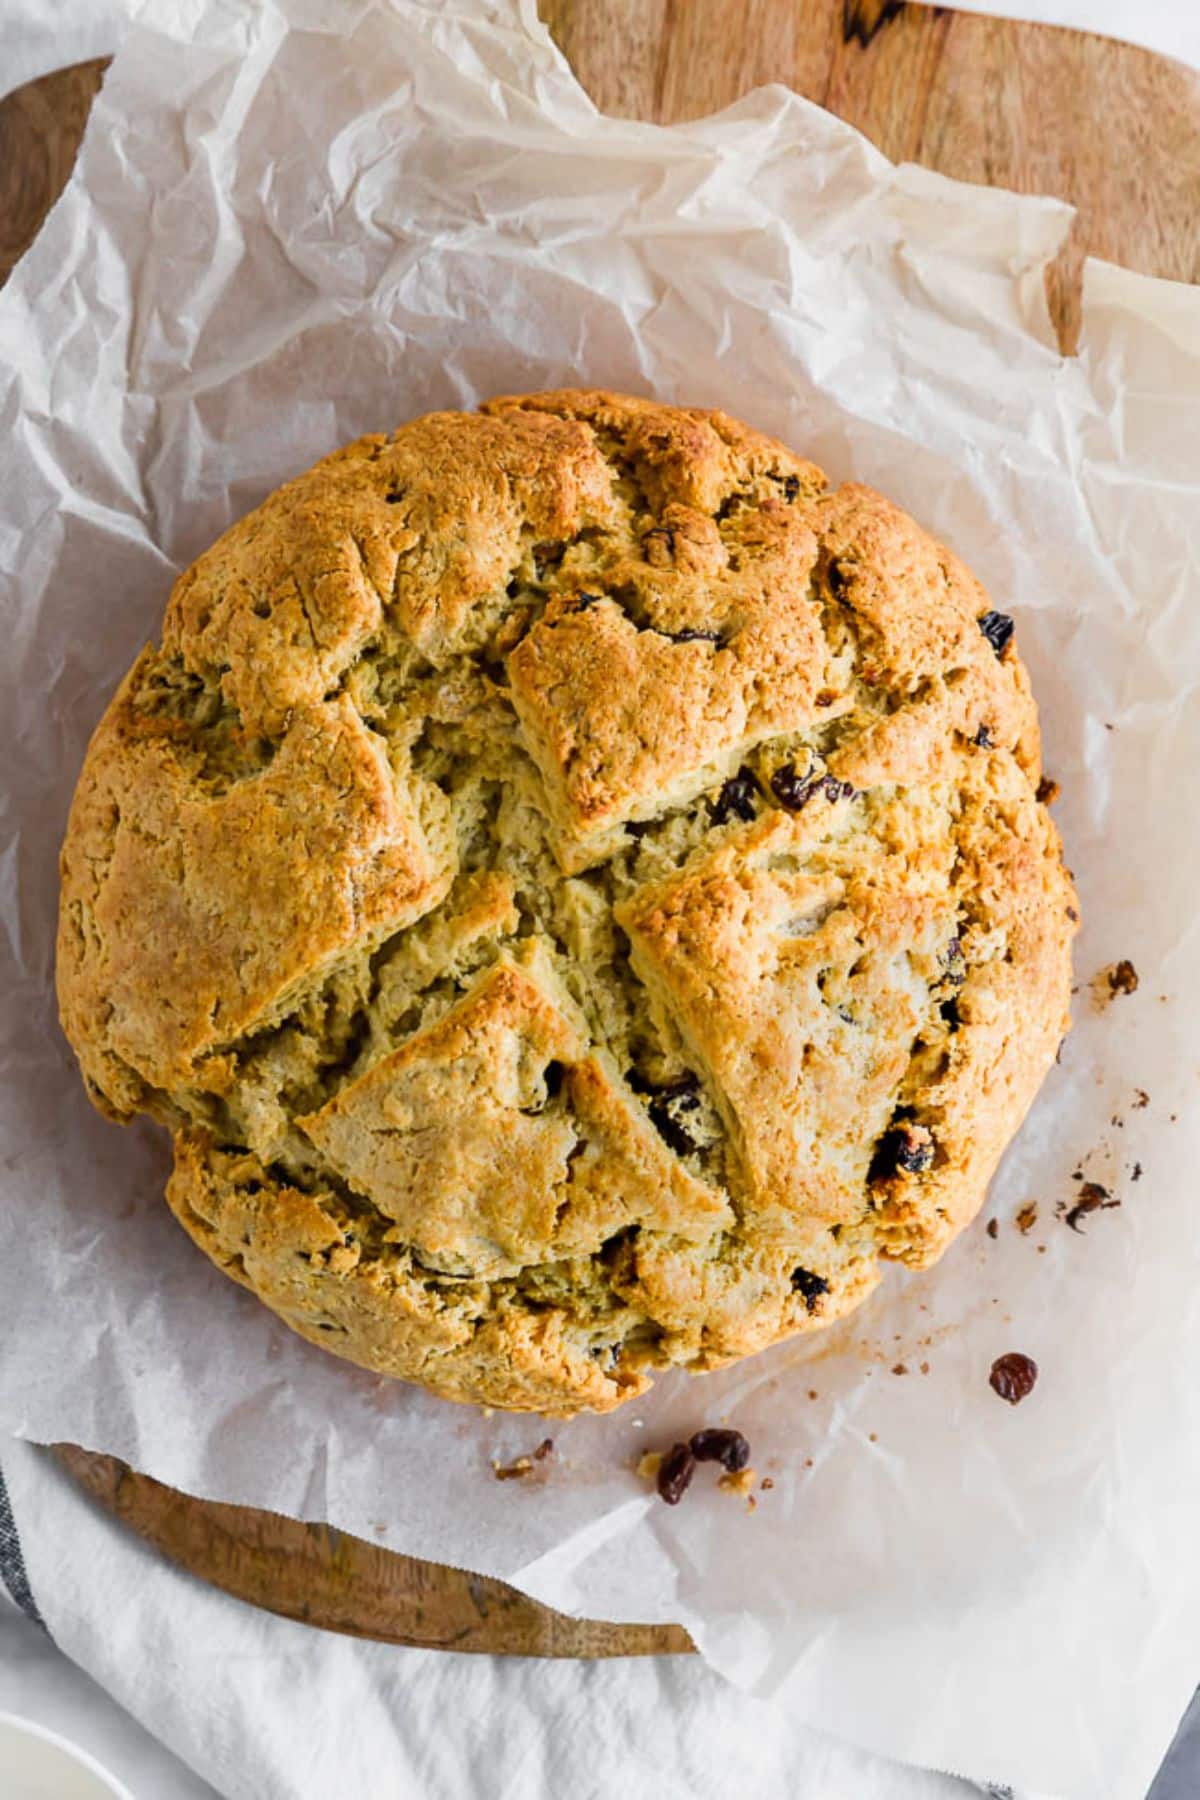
left=58, top=392, right=1076, bottom=1415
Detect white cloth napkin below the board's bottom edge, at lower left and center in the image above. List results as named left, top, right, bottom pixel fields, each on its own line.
left=0, top=1440, right=1021, bottom=1800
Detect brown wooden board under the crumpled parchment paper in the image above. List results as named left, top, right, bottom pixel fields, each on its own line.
left=0, top=0, right=1200, bottom=1656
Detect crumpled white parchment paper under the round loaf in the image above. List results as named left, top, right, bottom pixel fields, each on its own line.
left=0, top=0, right=1200, bottom=1800
